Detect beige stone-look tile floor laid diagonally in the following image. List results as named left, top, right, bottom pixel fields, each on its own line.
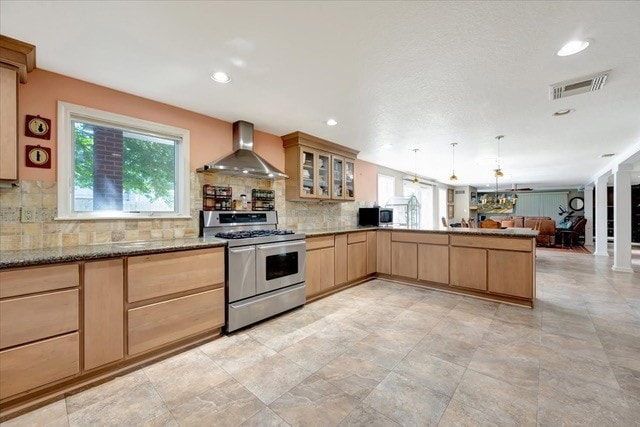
left=6, top=250, right=640, bottom=426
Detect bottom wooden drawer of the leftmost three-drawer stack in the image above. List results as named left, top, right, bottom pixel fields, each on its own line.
left=0, top=332, right=80, bottom=399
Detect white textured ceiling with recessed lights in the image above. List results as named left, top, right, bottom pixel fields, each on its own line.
left=0, top=0, right=640, bottom=188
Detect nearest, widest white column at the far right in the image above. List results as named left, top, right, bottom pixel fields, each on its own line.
left=611, top=164, right=633, bottom=273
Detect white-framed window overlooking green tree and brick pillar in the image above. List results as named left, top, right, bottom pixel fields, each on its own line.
left=56, top=101, right=191, bottom=220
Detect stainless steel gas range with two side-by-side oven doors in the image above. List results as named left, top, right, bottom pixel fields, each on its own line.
left=200, top=211, right=306, bottom=332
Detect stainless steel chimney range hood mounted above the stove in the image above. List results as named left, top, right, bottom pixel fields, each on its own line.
left=197, top=120, right=289, bottom=179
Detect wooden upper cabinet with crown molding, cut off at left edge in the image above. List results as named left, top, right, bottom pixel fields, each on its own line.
left=0, top=35, right=36, bottom=182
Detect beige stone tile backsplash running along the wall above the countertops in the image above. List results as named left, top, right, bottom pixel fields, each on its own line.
left=0, top=172, right=364, bottom=250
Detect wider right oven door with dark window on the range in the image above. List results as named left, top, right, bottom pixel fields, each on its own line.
left=256, top=240, right=307, bottom=294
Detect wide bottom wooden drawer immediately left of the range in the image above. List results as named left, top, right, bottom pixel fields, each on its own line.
left=128, top=288, right=224, bottom=355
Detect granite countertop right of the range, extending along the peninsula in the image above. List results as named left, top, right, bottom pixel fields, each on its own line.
left=296, top=225, right=538, bottom=239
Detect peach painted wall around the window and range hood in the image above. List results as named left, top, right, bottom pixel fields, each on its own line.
left=18, top=69, right=284, bottom=182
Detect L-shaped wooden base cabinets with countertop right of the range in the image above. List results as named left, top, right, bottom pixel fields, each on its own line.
left=305, top=227, right=538, bottom=307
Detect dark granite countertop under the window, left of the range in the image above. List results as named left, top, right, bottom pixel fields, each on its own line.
left=0, top=237, right=227, bottom=268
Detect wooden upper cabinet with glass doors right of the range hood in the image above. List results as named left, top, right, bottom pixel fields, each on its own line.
left=282, top=132, right=358, bottom=201
